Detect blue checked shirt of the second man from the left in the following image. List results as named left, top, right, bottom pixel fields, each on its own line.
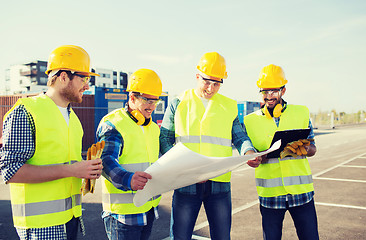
left=97, top=121, right=159, bottom=226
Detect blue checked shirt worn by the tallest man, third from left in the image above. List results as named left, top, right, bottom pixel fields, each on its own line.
left=160, top=98, right=256, bottom=195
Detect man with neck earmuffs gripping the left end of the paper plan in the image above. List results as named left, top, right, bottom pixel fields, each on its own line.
left=97, top=69, right=163, bottom=240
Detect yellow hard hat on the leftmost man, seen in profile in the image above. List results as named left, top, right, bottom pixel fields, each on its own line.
left=46, top=45, right=99, bottom=76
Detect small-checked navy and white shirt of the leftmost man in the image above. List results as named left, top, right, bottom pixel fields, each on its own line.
left=0, top=105, right=84, bottom=240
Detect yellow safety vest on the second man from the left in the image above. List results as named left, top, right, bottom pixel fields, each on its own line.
left=101, top=109, right=161, bottom=215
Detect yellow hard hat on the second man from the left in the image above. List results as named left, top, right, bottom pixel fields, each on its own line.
left=127, top=68, right=163, bottom=96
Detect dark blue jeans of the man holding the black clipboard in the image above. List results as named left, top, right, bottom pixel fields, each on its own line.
left=260, top=199, right=319, bottom=240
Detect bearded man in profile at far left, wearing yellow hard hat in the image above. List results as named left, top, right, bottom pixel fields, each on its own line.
left=0, top=45, right=102, bottom=240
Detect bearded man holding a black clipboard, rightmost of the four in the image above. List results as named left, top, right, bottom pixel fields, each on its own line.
left=244, top=64, right=319, bottom=240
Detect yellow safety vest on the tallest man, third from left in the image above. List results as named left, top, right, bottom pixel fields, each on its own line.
left=174, top=89, right=238, bottom=182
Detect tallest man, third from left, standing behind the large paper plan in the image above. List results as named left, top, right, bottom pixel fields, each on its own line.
left=160, top=52, right=255, bottom=240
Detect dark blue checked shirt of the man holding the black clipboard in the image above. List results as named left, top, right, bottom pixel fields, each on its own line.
left=259, top=117, right=315, bottom=209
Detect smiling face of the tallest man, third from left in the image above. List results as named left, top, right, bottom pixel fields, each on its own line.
left=196, top=74, right=222, bottom=99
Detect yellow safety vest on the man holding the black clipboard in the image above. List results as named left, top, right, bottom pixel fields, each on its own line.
left=244, top=105, right=314, bottom=197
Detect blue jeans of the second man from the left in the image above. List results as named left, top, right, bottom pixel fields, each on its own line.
left=103, top=208, right=155, bottom=240
